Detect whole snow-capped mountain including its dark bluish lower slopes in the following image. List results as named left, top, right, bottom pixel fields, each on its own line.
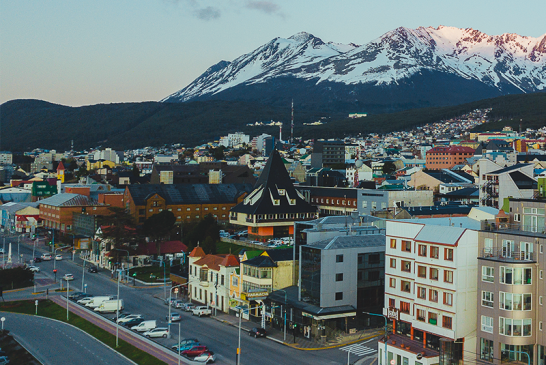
left=163, top=26, right=546, bottom=109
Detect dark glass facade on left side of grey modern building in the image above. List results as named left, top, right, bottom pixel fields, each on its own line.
left=300, top=247, right=321, bottom=306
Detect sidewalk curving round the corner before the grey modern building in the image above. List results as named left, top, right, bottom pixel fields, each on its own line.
left=212, top=313, right=383, bottom=351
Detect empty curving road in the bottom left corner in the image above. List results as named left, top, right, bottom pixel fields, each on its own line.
left=2, top=313, right=134, bottom=365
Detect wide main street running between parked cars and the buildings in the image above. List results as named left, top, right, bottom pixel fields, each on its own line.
left=5, top=233, right=377, bottom=365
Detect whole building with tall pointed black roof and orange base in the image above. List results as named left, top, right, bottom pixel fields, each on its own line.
left=229, top=150, right=317, bottom=241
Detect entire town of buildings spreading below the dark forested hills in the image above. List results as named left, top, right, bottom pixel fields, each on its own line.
left=0, top=109, right=546, bottom=365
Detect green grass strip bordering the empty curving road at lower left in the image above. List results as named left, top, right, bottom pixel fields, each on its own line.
left=0, top=300, right=165, bottom=365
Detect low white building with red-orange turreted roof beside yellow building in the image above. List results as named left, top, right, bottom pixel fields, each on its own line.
left=188, top=246, right=239, bottom=313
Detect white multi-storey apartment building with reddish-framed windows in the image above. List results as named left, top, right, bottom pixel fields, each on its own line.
left=378, top=217, right=480, bottom=365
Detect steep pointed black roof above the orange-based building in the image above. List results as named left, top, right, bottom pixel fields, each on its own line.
left=231, top=150, right=317, bottom=214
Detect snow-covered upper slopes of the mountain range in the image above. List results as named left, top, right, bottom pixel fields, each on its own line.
left=164, top=26, right=546, bottom=101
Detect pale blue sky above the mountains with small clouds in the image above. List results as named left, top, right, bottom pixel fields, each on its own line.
left=0, top=0, right=546, bottom=106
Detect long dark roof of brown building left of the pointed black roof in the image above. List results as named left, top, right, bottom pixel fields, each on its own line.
left=127, top=184, right=252, bottom=205
